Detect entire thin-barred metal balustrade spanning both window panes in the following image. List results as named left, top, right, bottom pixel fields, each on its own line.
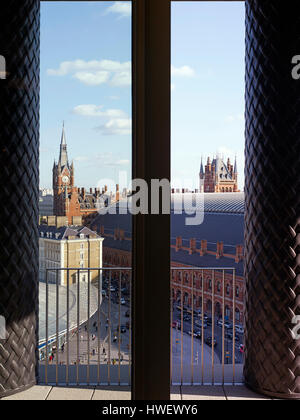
left=39, top=267, right=243, bottom=386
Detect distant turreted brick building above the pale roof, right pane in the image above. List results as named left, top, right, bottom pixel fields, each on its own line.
left=199, top=156, right=239, bottom=193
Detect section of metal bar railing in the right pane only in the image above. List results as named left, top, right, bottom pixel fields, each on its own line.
left=170, top=267, right=244, bottom=385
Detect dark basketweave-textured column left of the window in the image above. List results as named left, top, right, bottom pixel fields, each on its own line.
left=0, top=0, right=40, bottom=397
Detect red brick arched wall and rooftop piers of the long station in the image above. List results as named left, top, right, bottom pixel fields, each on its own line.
left=99, top=226, right=245, bottom=324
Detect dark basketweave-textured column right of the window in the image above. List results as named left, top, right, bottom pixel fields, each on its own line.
left=244, top=0, right=300, bottom=398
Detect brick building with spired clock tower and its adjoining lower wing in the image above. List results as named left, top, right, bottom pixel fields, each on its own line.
left=52, top=123, right=101, bottom=224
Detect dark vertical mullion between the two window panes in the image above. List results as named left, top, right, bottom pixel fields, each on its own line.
left=40, top=0, right=244, bottom=400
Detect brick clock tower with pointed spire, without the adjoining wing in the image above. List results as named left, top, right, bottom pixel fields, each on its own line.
left=52, top=125, right=80, bottom=223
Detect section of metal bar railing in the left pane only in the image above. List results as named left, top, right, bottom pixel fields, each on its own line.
left=39, top=267, right=131, bottom=386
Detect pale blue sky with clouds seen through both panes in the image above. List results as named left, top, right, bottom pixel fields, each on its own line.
left=40, top=2, right=244, bottom=187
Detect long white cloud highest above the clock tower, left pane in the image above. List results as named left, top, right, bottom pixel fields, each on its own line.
left=47, top=60, right=131, bottom=86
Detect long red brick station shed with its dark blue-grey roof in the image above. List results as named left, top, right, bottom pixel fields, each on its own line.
left=91, top=193, right=245, bottom=324
